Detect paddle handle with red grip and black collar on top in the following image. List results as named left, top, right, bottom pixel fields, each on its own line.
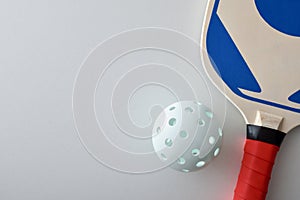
left=233, top=125, right=285, bottom=200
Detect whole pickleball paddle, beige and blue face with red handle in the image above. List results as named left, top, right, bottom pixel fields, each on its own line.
left=201, top=0, right=300, bottom=200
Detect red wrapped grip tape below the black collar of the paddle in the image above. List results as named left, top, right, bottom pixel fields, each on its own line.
left=233, top=139, right=279, bottom=200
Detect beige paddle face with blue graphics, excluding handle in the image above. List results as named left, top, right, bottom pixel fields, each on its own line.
left=201, top=0, right=300, bottom=132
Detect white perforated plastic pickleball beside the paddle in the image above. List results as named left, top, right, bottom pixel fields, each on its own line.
left=152, top=101, right=223, bottom=172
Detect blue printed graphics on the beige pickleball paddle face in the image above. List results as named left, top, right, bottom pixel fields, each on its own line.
left=206, top=0, right=300, bottom=113
